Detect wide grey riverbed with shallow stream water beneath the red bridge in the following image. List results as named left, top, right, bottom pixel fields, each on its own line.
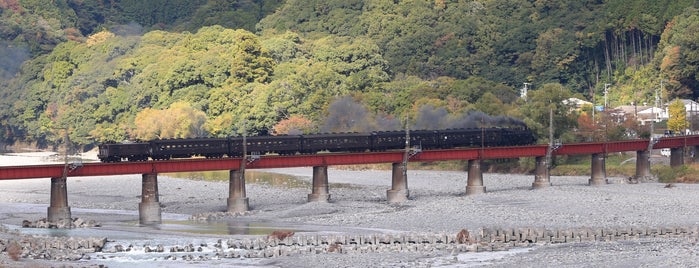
left=0, top=154, right=699, bottom=267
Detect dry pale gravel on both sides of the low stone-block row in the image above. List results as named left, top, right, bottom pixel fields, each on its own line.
left=0, top=154, right=699, bottom=267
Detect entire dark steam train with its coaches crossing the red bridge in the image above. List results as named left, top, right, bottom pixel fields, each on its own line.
left=97, top=128, right=536, bottom=162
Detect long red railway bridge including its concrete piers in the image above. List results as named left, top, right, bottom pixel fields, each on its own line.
left=0, top=135, right=699, bottom=224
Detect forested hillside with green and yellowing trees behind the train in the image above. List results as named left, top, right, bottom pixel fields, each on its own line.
left=0, top=0, right=699, bottom=150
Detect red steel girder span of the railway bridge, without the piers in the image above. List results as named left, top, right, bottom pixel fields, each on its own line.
left=0, top=135, right=699, bottom=180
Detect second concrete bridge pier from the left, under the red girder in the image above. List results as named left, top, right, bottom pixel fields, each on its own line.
left=138, top=173, right=162, bottom=225
